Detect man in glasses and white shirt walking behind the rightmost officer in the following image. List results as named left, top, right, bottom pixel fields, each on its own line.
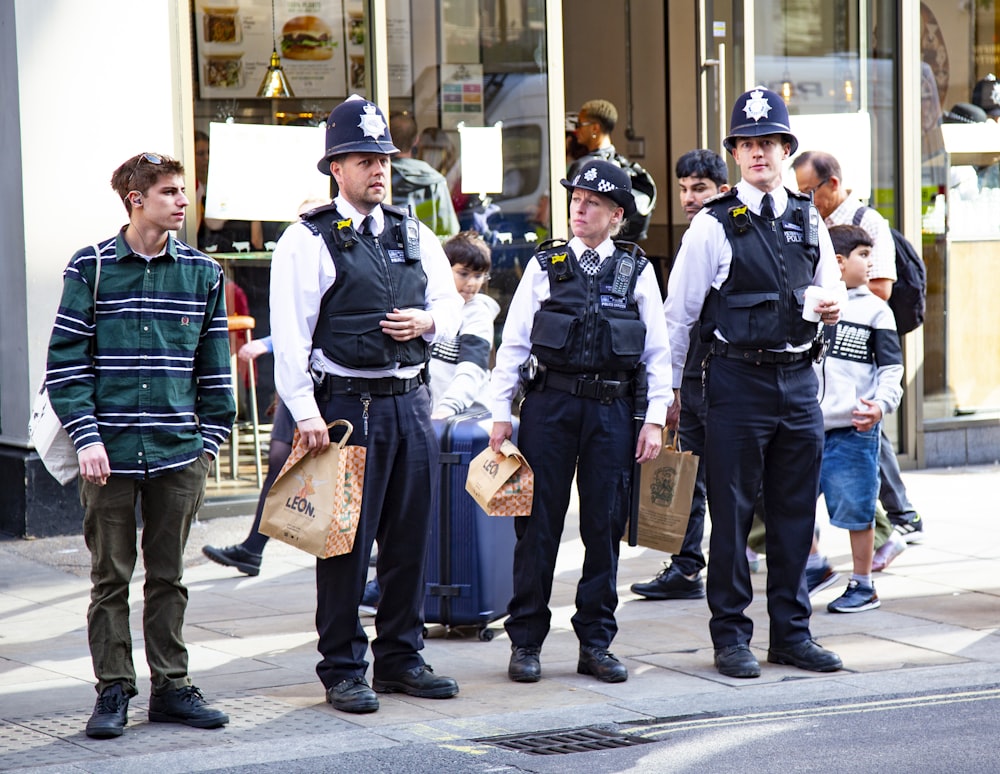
left=792, top=151, right=924, bottom=556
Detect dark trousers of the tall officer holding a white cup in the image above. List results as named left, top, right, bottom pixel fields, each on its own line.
left=705, top=357, right=823, bottom=648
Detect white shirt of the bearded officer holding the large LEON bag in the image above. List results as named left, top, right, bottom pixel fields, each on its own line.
left=271, top=196, right=464, bottom=422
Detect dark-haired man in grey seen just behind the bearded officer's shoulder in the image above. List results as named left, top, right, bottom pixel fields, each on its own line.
left=389, top=113, right=458, bottom=236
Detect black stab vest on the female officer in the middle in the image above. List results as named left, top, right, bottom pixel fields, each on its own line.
left=531, top=245, right=647, bottom=373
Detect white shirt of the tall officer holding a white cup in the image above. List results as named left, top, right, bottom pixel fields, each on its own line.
left=663, top=180, right=840, bottom=389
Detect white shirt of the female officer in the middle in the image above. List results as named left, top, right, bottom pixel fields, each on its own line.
left=490, top=237, right=674, bottom=425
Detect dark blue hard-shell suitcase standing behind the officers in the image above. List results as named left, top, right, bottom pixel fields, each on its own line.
left=424, top=409, right=518, bottom=642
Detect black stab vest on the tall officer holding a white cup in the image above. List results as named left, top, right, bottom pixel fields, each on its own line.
left=701, top=189, right=819, bottom=350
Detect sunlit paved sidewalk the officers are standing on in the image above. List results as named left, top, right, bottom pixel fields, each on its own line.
left=0, top=465, right=1000, bottom=774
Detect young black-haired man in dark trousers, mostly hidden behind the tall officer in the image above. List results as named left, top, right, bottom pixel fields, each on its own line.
left=631, top=148, right=729, bottom=599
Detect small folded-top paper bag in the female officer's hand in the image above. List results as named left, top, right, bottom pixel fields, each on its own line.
left=465, top=441, right=535, bottom=516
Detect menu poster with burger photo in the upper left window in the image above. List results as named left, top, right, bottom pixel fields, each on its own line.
left=194, top=0, right=347, bottom=99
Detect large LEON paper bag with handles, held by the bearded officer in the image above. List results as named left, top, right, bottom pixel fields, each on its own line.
left=259, top=419, right=367, bottom=559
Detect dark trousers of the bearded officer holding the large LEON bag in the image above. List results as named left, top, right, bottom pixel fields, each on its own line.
left=316, top=386, right=440, bottom=688
